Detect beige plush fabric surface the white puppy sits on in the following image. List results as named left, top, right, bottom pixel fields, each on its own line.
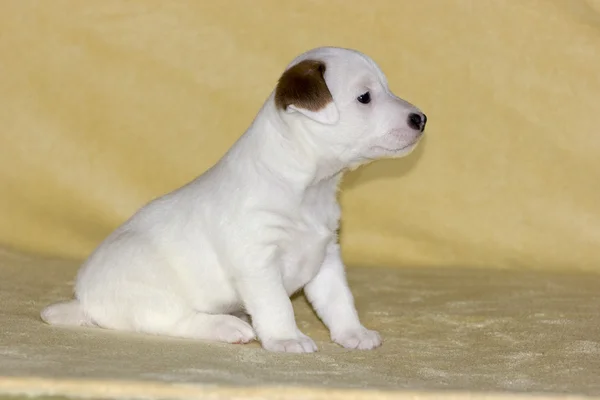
left=0, top=251, right=600, bottom=398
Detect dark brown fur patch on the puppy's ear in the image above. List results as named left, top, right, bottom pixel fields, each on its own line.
left=275, top=60, right=333, bottom=111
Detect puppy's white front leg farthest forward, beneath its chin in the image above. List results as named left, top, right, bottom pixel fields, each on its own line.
left=304, top=242, right=381, bottom=350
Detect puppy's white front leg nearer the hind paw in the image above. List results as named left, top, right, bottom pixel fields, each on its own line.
left=237, top=250, right=317, bottom=353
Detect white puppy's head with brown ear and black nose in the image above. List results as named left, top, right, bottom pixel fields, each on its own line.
left=274, top=47, right=427, bottom=166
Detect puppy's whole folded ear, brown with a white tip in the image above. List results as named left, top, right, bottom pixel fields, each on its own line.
left=275, top=60, right=340, bottom=125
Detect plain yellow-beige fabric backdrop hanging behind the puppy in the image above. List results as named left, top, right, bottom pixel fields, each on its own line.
left=0, top=0, right=600, bottom=270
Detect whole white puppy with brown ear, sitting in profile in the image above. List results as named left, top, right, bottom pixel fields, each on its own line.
left=42, top=47, right=426, bottom=352
